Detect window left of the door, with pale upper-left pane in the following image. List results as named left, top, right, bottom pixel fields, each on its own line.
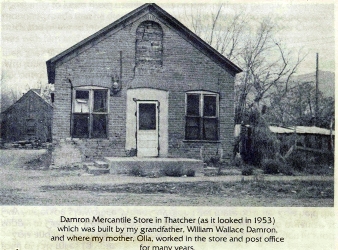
left=72, top=88, right=108, bottom=138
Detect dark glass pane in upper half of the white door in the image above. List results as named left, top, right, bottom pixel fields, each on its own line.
left=138, top=103, right=156, bottom=130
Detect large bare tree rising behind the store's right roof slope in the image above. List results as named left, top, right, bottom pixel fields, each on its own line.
left=177, top=4, right=305, bottom=123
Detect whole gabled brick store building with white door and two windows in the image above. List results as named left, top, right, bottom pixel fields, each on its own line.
left=47, top=4, right=241, bottom=164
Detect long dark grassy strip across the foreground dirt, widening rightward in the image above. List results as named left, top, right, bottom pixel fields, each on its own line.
left=41, top=180, right=334, bottom=199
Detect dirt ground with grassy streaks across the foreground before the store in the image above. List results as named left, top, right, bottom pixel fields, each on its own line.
left=0, top=149, right=334, bottom=207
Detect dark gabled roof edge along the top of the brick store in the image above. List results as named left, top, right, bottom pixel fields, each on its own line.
left=46, top=3, right=242, bottom=83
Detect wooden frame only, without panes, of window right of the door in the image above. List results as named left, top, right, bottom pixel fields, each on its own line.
left=184, top=90, right=220, bottom=142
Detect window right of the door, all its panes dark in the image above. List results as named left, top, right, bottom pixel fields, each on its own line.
left=185, top=91, right=218, bottom=140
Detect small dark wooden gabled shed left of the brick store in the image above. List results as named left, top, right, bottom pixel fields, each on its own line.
left=1, top=89, right=53, bottom=142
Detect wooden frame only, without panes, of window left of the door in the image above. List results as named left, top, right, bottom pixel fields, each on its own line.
left=71, top=86, right=110, bottom=139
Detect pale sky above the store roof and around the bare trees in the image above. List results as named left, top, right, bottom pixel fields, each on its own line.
left=0, top=1, right=335, bottom=106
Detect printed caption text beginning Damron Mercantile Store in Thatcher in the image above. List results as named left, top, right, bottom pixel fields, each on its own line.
left=50, top=215, right=285, bottom=250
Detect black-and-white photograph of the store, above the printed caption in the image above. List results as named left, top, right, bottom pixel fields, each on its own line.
left=0, top=1, right=336, bottom=206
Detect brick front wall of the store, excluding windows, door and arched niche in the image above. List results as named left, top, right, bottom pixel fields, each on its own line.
left=53, top=10, right=234, bottom=161
